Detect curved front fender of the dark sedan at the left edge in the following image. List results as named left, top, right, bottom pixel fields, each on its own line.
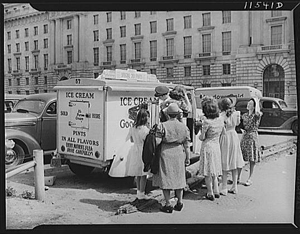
left=5, top=129, right=41, bottom=155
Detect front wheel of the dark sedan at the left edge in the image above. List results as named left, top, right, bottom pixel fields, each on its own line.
left=5, top=144, right=25, bottom=168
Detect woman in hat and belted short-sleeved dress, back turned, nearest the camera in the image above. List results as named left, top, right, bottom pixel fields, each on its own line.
left=153, top=103, right=190, bottom=213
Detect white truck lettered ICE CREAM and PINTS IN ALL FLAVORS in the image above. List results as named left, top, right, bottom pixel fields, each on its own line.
left=55, top=69, right=196, bottom=177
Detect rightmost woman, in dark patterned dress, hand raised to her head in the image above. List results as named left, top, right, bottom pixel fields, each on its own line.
left=238, top=98, right=262, bottom=186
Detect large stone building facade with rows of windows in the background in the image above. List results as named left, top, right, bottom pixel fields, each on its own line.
left=4, top=4, right=297, bottom=106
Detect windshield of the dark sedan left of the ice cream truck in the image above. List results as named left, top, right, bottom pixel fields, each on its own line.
left=13, top=99, right=46, bottom=114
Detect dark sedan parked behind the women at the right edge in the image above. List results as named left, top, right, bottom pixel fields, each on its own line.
left=235, top=97, right=298, bottom=135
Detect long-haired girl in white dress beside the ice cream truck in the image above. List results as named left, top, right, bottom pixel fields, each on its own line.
left=126, top=108, right=150, bottom=199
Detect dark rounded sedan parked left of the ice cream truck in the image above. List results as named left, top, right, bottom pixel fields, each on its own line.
left=5, top=93, right=57, bottom=167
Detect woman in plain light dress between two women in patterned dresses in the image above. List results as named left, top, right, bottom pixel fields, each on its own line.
left=220, top=98, right=245, bottom=196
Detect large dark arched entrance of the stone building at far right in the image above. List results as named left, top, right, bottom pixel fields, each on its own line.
left=263, top=64, right=284, bottom=99
